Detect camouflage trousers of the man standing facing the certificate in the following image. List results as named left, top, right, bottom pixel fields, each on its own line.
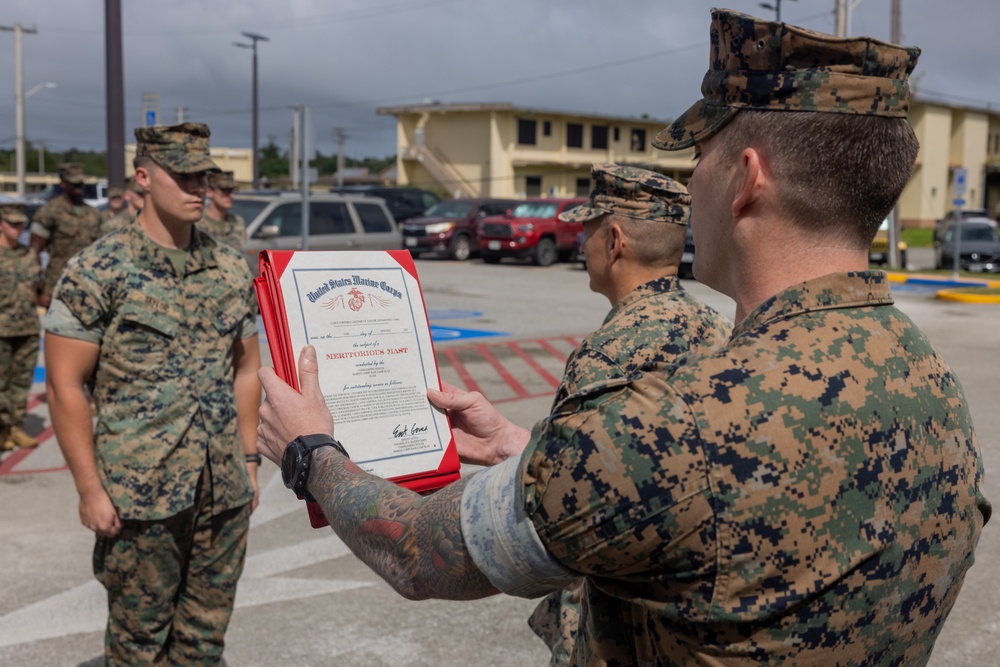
left=94, top=469, right=250, bottom=665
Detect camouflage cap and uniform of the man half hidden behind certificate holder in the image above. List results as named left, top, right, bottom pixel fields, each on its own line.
left=529, top=164, right=732, bottom=665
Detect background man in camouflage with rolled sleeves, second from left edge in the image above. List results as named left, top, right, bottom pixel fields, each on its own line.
left=31, top=162, right=101, bottom=307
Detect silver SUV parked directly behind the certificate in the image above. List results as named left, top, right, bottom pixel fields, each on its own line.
left=232, top=193, right=402, bottom=274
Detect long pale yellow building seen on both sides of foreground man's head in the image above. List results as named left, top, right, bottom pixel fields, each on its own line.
left=378, top=100, right=1000, bottom=227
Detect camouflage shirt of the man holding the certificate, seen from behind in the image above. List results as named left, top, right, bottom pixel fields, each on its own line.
left=521, top=272, right=990, bottom=666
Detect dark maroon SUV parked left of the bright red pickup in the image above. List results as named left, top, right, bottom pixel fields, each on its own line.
left=402, top=197, right=521, bottom=261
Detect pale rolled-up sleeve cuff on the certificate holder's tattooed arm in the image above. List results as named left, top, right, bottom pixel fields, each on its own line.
left=461, top=458, right=577, bottom=598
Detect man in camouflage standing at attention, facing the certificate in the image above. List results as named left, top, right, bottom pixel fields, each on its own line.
left=44, top=123, right=260, bottom=664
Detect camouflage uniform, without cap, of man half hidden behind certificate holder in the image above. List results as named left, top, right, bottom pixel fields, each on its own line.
left=530, top=276, right=732, bottom=662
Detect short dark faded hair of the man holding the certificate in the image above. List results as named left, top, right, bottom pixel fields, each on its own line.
left=719, top=110, right=920, bottom=247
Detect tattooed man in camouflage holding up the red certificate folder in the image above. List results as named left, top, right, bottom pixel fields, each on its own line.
left=248, top=10, right=991, bottom=667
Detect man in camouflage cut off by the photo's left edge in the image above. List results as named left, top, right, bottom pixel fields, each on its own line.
left=0, top=204, right=41, bottom=451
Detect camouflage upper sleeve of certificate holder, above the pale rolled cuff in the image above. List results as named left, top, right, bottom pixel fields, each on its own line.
left=522, top=375, right=716, bottom=577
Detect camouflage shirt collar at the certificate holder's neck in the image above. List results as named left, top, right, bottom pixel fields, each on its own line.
left=733, top=271, right=894, bottom=338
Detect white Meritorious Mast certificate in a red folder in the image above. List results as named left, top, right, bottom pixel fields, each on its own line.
left=254, top=250, right=459, bottom=526
